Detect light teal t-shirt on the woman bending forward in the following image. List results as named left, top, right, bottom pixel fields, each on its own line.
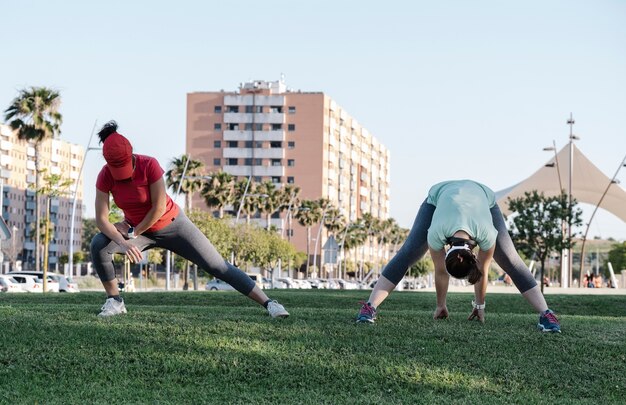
left=426, top=180, right=498, bottom=250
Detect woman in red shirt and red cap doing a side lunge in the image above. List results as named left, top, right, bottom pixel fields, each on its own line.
left=91, top=121, right=289, bottom=318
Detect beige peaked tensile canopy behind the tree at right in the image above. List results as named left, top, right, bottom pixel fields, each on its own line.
left=496, top=144, right=626, bottom=222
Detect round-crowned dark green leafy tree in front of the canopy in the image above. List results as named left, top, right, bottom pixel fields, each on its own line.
left=509, top=190, right=582, bottom=292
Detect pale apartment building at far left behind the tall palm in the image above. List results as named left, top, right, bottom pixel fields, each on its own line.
left=0, top=121, right=84, bottom=271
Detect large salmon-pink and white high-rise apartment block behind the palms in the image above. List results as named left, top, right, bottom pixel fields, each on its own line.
left=186, top=80, right=390, bottom=266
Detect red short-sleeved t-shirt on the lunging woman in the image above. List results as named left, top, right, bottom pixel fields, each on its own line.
left=96, top=155, right=178, bottom=232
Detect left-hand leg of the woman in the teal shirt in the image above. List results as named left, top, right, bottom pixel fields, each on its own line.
left=368, top=201, right=435, bottom=307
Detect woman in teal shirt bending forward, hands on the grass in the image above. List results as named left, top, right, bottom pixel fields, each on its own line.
left=357, top=180, right=561, bottom=332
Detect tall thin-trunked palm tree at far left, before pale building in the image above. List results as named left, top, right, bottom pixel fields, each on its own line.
left=4, top=87, right=63, bottom=271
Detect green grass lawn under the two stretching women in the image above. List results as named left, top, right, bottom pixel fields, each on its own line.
left=0, top=290, right=626, bottom=404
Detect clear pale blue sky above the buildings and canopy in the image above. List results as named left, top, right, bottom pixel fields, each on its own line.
left=0, top=0, right=626, bottom=239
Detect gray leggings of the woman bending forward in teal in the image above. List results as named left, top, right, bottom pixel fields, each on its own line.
left=383, top=201, right=537, bottom=293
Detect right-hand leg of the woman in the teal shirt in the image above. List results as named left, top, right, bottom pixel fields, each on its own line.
left=491, top=205, right=548, bottom=312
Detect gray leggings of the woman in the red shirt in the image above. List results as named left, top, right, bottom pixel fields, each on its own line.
left=91, top=210, right=255, bottom=295
